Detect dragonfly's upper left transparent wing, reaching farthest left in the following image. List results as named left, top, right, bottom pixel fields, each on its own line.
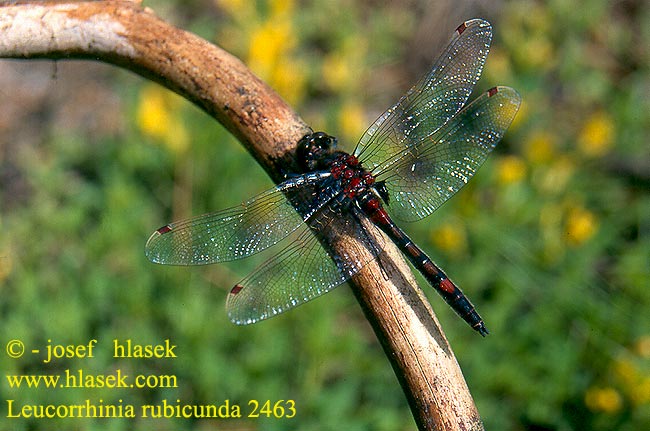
left=145, top=172, right=337, bottom=265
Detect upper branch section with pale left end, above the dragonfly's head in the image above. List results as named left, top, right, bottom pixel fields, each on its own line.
left=0, top=1, right=310, bottom=182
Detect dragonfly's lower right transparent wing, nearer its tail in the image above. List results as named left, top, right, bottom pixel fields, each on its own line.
left=378, top=87, right=521, bottom=221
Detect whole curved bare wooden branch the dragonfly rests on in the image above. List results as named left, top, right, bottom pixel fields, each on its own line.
left=0, top=1, right=483, bottom=430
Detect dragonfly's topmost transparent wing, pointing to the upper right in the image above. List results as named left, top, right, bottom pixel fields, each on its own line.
left=354, top=19, right=492, bottom=171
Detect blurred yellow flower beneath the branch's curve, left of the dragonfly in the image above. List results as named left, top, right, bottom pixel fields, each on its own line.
left=136, top=85, right=189, bottom=153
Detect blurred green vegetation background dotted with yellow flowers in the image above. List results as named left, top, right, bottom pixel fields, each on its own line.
left=0, top=0, right=650, bottom=431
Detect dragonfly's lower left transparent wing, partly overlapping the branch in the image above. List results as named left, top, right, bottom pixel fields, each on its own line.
left=226, top=205, right=383, bottom=325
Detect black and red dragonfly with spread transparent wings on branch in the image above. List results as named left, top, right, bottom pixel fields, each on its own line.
left=145, top=19, right=521, bottom=336
